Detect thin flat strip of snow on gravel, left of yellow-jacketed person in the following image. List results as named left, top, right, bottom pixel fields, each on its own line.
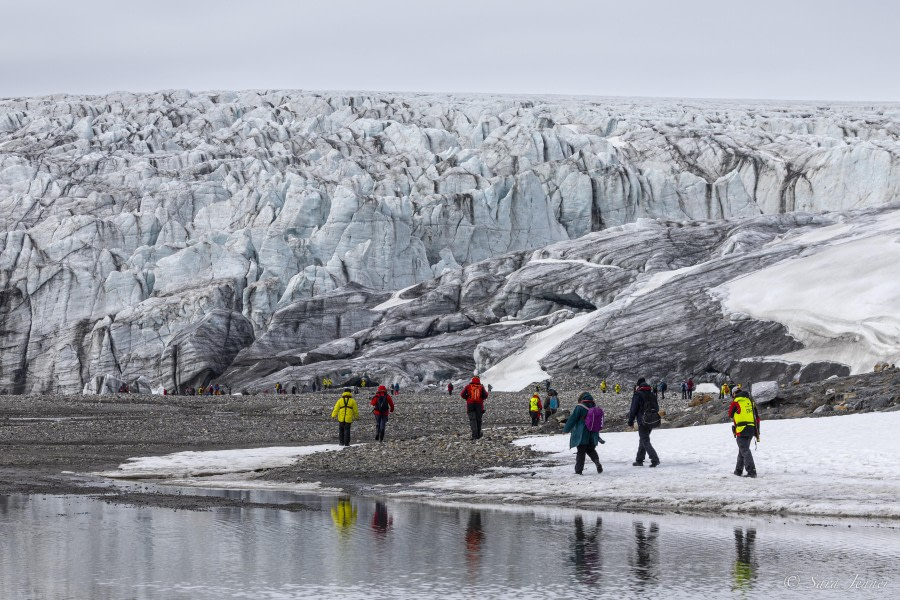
left=96, top=444, right=341, bottom=479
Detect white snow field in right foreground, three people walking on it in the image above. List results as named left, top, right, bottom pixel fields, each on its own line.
left=401, top=412, right=900, bottom=519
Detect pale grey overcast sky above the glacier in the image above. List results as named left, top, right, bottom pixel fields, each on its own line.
left=0, top=0, right=900, bottom=101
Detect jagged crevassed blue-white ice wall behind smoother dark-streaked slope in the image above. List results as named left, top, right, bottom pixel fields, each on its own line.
left=0, top=91, right=900, bottom=392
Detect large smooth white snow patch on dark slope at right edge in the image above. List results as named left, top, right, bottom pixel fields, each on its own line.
left=711, top=211, right=900, bottom=374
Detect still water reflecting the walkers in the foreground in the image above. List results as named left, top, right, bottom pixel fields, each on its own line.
left=0, top=490, right=900, bottom=600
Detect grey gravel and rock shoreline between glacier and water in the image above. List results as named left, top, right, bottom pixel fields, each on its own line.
left=0, top=369, right=900, bottom=508
